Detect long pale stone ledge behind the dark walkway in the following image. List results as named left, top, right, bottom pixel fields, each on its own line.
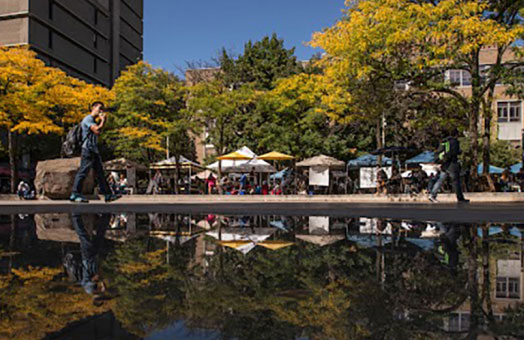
left=0, top=192, right=524, bottom=206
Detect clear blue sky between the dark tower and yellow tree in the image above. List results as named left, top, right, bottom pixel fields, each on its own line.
left=144, top=0, right=344, bottom=72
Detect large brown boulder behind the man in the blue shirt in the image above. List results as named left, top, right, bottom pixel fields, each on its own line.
left=35, top=158, right=95, bottom=199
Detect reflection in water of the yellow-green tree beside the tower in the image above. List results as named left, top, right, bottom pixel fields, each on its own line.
left=101, top=239, right=190, bottom=336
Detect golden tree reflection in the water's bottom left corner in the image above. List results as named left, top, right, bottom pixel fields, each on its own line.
left=0, top=267, right=110, bottom=340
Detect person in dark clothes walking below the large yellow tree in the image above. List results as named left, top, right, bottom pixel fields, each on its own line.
left=429, top=129, right=469, bottom=203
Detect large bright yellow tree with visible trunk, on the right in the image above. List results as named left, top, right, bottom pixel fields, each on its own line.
left=312, top=0, right=524, bottom=179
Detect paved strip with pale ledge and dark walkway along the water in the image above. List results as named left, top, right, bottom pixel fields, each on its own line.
left=0, top=194, right=524, bottom=223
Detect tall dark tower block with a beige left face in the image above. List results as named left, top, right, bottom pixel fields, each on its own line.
left=0, top=0, right=144, bottom=87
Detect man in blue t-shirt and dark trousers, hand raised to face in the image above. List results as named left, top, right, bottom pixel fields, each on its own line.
left=69, top=101, right=118, bottom=203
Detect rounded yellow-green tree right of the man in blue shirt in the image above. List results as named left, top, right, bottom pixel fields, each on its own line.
left=107, top=62, right=194, bottom=170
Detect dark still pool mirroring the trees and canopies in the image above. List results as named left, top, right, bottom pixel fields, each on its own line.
left=0, top=213, right=524, bottom=340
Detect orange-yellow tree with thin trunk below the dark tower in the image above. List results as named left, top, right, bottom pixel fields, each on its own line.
left=0, top=47, right=111, bottom=192
